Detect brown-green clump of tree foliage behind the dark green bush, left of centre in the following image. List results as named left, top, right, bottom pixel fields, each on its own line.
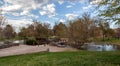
left=19, top=22, right=51, bottom=38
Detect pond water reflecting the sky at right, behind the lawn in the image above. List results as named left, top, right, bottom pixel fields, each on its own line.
left=81, top=44, right=120, bottom=51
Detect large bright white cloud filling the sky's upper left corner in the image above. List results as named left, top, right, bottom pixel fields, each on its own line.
left=0, top=0, right=48, bottom=17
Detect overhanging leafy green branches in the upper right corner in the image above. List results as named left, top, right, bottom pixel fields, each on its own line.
left=99, top=0, right=120, bottom=24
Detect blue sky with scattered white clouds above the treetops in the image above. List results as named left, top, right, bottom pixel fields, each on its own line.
left=0, top=0, right=100, bottom=31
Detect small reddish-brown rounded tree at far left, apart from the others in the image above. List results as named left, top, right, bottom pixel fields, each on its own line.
left=4, top=25, right=15, bottom=39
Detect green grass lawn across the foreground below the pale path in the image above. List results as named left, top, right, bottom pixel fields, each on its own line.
left=0, top=51, right=120, bottom=66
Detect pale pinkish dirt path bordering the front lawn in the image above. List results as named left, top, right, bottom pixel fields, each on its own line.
left=0, top=45, right=77, bottom=57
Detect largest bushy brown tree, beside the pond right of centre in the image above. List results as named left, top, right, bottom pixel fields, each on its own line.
left=69, top=13, right=95, bottom=44
